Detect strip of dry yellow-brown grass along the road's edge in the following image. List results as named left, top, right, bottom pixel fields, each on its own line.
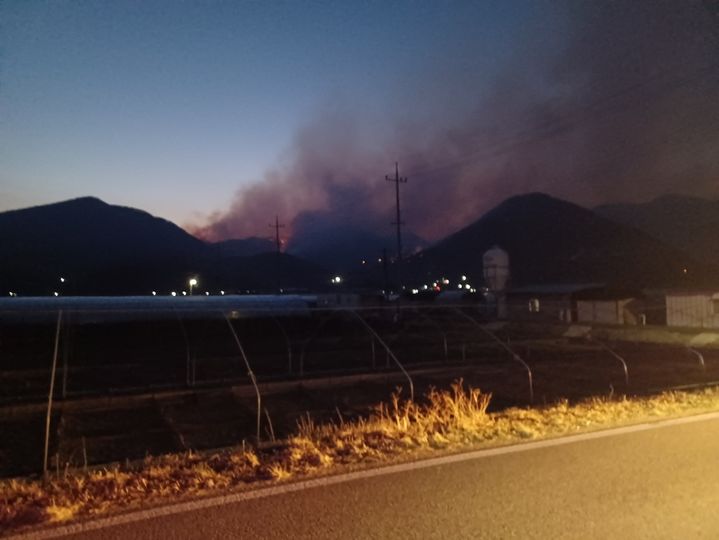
left=0, top=381, right=719, bottom=531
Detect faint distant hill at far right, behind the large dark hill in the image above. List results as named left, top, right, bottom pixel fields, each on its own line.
left=595, top=195, right=719, bottom=264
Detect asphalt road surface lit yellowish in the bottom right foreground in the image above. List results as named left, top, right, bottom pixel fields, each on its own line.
left=16, top=418, right=719, bottom=540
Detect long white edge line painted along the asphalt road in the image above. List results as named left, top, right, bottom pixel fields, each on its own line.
left=8, top=411, right=719, bottom=540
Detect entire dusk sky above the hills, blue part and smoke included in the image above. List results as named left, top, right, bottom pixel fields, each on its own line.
left=0, top=0, right=719, bottom=240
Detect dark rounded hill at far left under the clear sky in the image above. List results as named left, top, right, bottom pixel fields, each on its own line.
left=0, top=197, right=207, bottom=294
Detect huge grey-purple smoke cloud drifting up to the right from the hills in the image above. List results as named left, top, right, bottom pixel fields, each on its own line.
left=191, top=0, right=719, bottom=240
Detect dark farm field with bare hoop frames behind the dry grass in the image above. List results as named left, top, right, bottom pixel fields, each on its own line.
left=0, top=309, right=719, bottom=476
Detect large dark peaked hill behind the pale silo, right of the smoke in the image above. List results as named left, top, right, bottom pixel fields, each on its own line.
left=406, top=193, right=719, bottom=288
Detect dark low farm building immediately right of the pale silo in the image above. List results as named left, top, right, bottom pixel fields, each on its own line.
left=507, top=283, right=604, bottom=323
